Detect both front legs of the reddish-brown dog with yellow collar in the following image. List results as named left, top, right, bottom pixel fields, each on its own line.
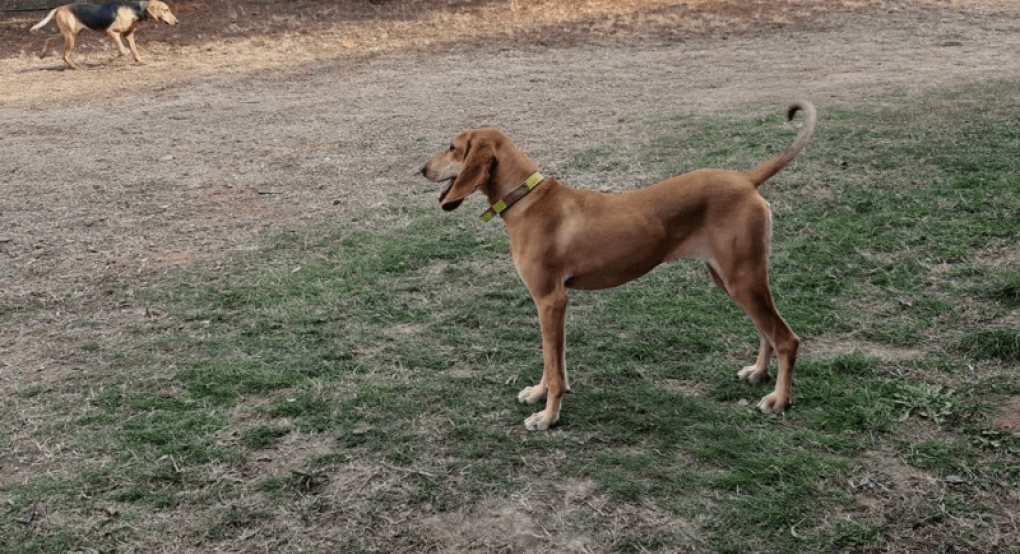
left=517, top=288, right=570, bottom=431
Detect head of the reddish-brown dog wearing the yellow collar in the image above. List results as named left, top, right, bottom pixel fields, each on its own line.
left=421, top=129, right=508, bottom=211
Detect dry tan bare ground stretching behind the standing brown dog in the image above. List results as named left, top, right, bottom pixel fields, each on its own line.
left=0, top=0, right=1020, bottom=547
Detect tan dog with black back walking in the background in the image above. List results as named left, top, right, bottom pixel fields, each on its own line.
left=30, top=0, right=177, bottom=69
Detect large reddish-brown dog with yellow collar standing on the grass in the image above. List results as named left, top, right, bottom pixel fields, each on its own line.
left=421, top=102, right=816, bottom=431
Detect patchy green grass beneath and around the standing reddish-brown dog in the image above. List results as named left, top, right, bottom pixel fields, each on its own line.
left=0, top=81, right=1020, bottom=552
